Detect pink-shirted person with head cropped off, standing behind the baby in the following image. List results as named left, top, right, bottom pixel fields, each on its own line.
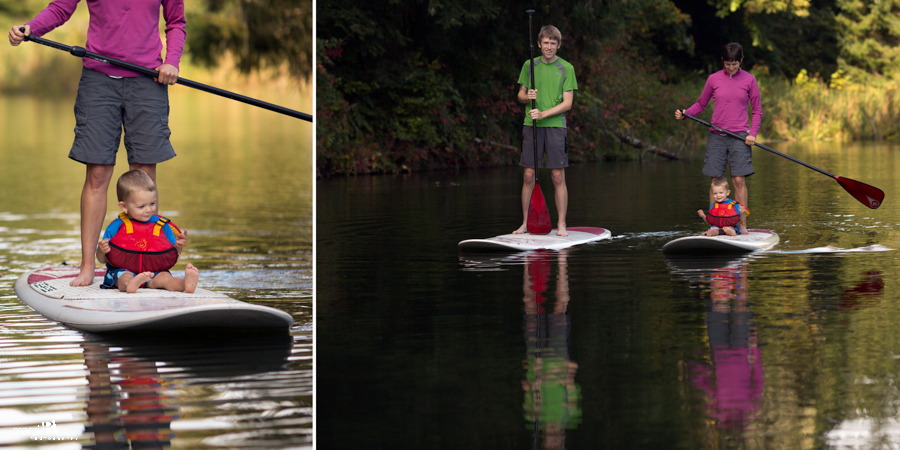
left=9, top=0, right=186, bottom=286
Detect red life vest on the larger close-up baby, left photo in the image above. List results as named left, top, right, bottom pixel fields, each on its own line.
left=106, top=213, right=181, bottom=273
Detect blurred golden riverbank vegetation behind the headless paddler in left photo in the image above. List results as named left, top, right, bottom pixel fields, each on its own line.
left=0, top=0, right=313, bottom=97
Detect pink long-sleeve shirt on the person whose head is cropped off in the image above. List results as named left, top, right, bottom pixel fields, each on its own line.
left=28, top=0, right=186, bottom=77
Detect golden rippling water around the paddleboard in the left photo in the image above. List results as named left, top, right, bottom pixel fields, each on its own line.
left=0, top=88, right=313, bottom=449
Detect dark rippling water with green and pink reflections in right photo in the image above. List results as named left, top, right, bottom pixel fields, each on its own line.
left=316, top=139, right=900, bottom=449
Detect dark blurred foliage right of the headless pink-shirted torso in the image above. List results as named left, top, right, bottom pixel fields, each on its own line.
left=186, top=0, right=312, bottom=79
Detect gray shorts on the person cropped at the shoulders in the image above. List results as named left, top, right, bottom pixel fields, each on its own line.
left=69, top=69, right=175, bottom=164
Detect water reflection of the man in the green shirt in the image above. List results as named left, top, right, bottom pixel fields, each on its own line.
left=522, top=250, right=581, bottom=449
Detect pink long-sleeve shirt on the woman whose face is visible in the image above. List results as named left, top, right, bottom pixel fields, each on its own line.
left=685, top=69, right=762, bottom=137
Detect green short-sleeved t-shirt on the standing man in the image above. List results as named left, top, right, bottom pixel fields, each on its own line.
left=519, top=56, right=578, bottom=128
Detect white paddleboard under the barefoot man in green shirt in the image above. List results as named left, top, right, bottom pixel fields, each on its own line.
left=459, top=227, right=612, bottom=251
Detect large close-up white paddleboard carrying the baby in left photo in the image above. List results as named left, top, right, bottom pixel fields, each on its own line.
left=14, top=266, right=294, bottom=332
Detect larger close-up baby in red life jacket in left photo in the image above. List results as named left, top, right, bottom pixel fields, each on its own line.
left=97, top=169, right=200, bottom=294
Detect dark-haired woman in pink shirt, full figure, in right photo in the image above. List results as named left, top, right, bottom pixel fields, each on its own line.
left=675, top=42, right=762, bottom=234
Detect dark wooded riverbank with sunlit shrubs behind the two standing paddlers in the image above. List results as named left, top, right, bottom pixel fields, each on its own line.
left=316, top=0, right=900, bottom=176
